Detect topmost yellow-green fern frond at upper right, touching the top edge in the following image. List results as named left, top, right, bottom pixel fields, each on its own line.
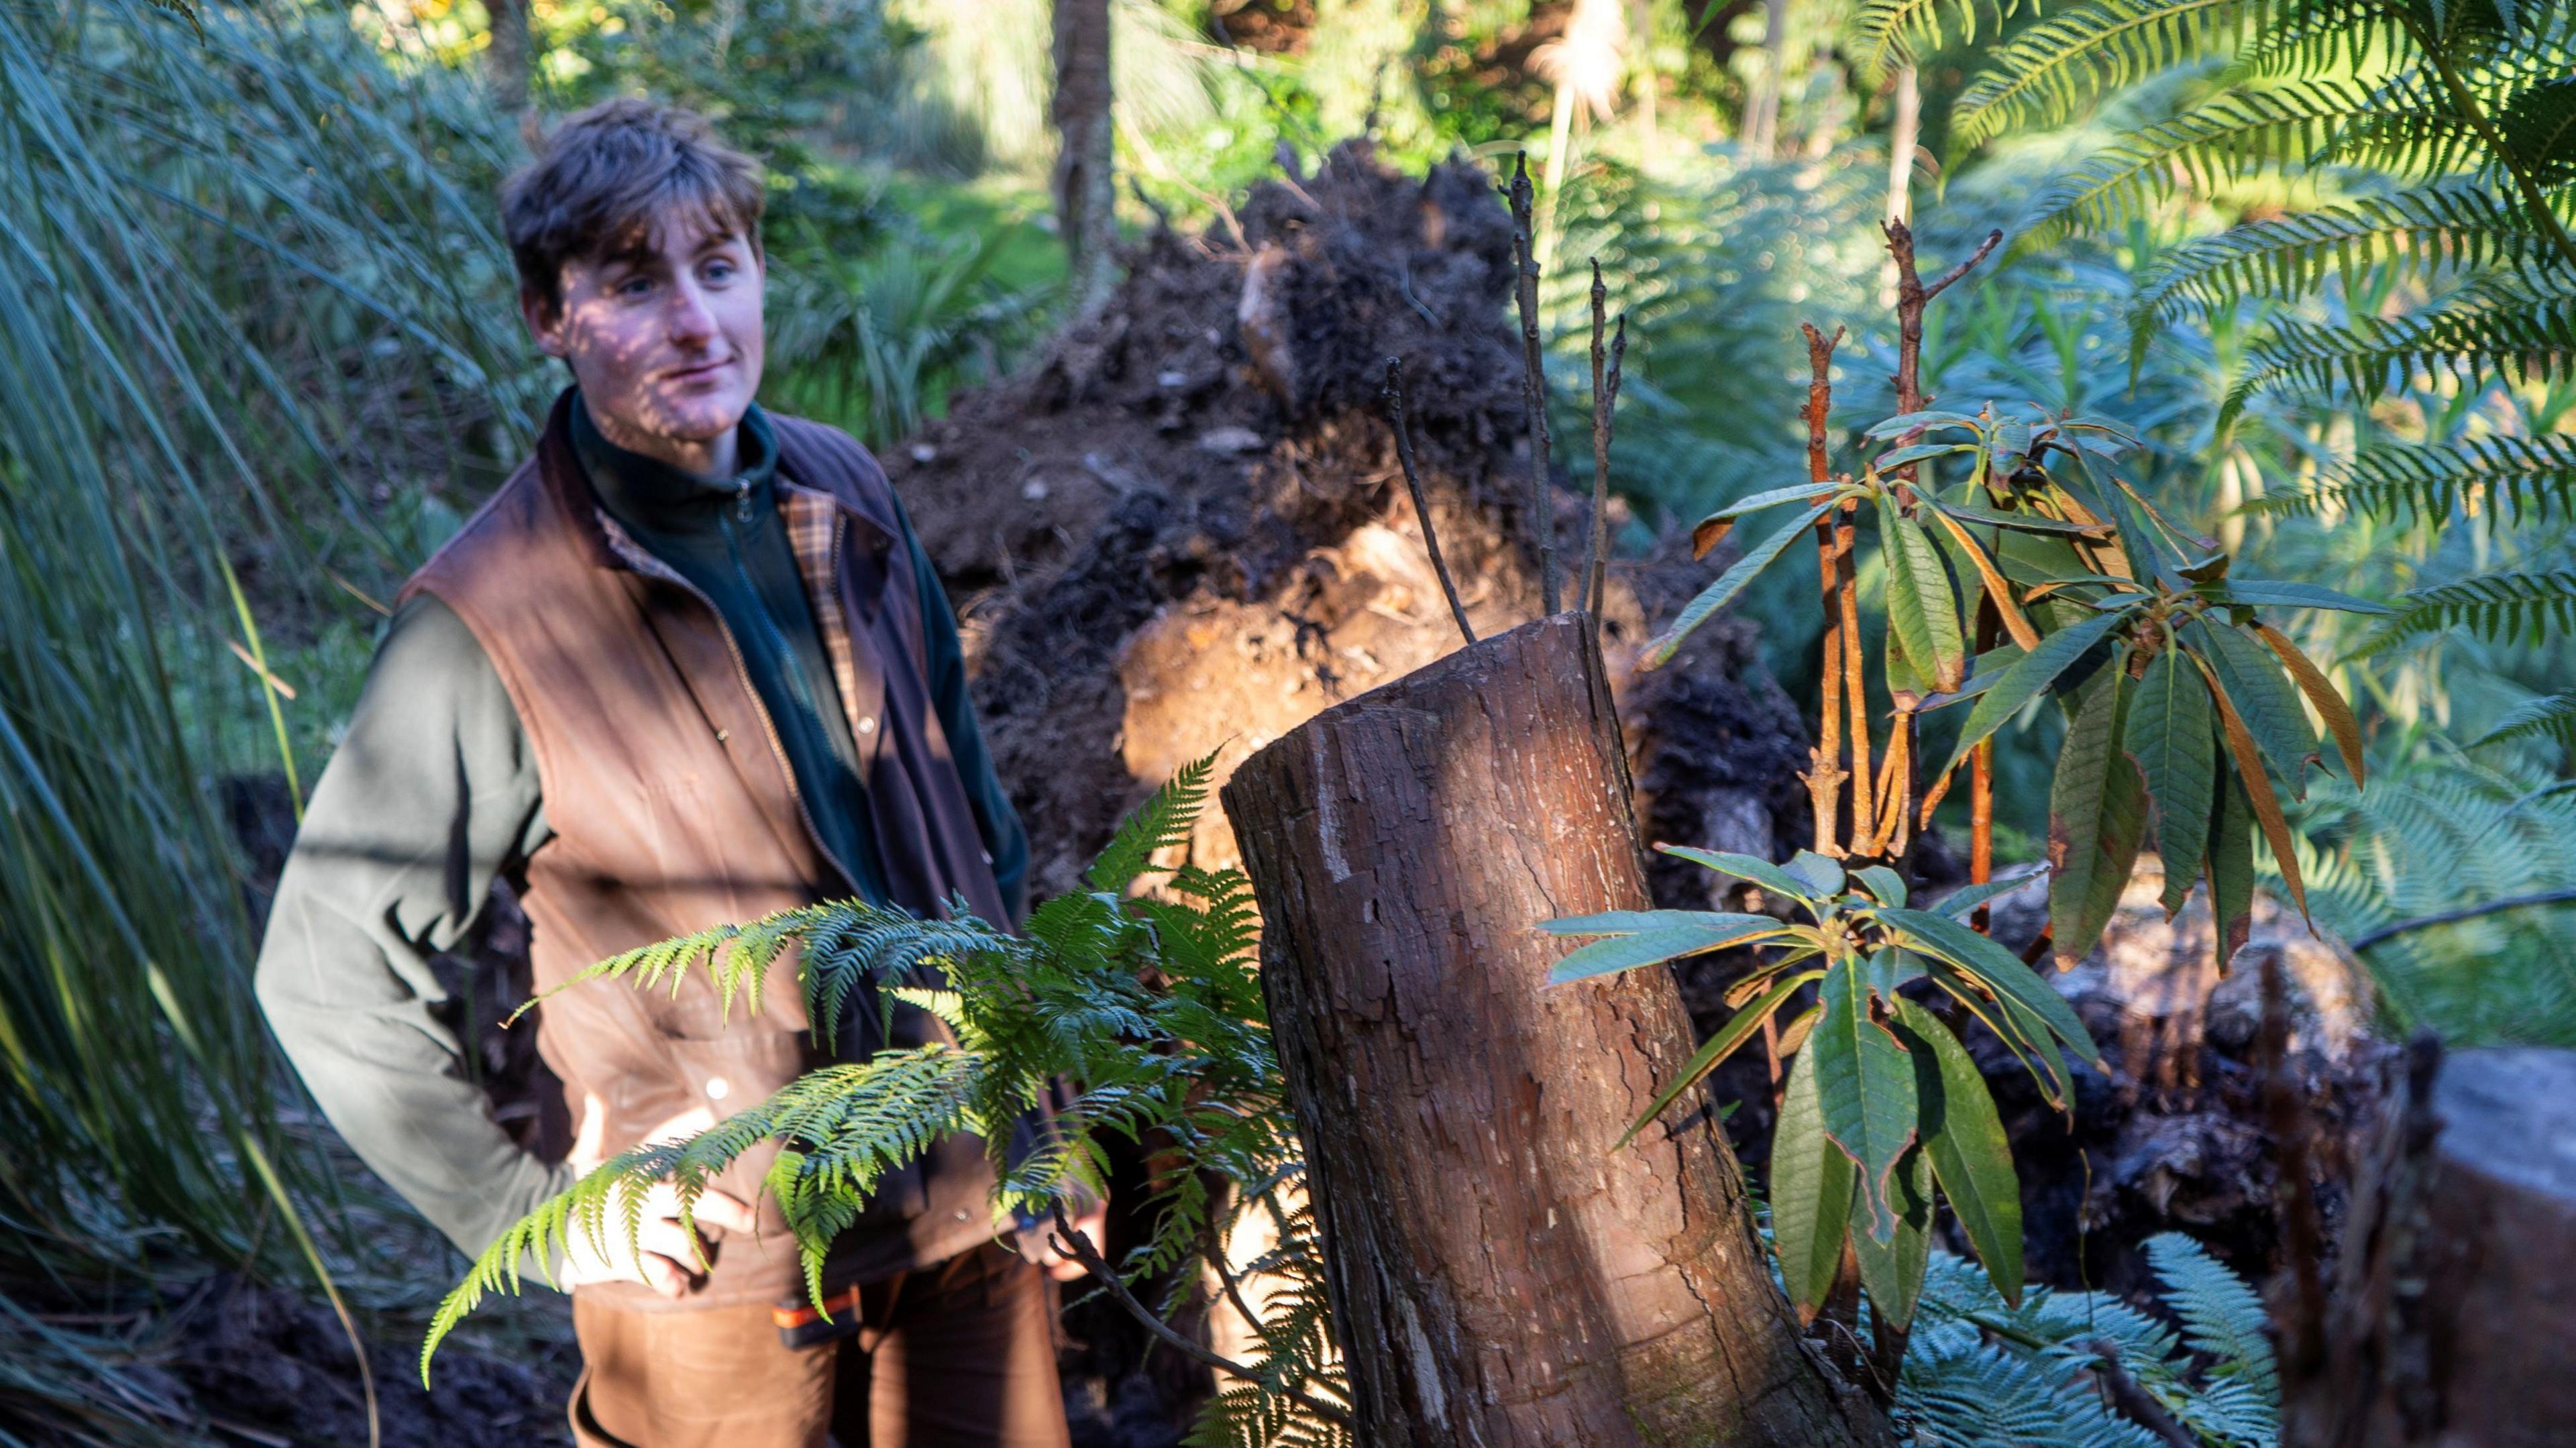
left=1950, top=0, right=2262, bottom=147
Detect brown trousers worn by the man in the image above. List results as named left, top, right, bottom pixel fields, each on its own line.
left=572, top=1247, right=1069, bottom=1448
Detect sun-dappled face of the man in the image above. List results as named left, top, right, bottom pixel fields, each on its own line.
left=523, top=206, right=763, bottom=471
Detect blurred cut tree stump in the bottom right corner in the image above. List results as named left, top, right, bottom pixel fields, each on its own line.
left=2282, top=1044, right=2576, bottom=1448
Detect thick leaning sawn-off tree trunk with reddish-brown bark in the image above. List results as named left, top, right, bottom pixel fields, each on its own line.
left=1224, top=613, right=1886, bottom=1448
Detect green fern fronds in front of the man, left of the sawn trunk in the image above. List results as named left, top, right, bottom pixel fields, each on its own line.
left=420, top=755, right=1347, bottom=1443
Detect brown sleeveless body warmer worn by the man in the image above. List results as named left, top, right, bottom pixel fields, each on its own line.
left=405, top=394, right=1007, bottom=1306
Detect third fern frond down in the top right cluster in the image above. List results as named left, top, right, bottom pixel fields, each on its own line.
left=2131, top=188, right=2558, bottom=327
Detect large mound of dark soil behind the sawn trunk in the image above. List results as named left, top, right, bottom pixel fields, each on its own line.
left=886, top=142, right=1806, bottom=902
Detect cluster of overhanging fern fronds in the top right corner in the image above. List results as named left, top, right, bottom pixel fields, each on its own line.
left=1876, top=0, right=2576, bottom=690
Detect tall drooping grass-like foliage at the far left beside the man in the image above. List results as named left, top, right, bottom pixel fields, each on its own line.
left=0, top=0, right=533, bottom=1314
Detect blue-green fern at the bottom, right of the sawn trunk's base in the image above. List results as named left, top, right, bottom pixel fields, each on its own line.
left=1896, top=1231, right=2279, bottom=1448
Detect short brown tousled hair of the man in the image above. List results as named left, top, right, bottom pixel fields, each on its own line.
left=500, top=98, right=765, bottom=309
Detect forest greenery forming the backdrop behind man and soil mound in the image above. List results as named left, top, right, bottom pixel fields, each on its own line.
left=0, top=0, right=2576, bottom=1443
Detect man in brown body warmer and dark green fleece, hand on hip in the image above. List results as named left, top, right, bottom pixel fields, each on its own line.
left=258, top=101, right=1097, bottom=1448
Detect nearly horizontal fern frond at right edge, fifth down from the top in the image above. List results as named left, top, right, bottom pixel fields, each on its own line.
left=2246, top=433, right=2576, bottom=523
